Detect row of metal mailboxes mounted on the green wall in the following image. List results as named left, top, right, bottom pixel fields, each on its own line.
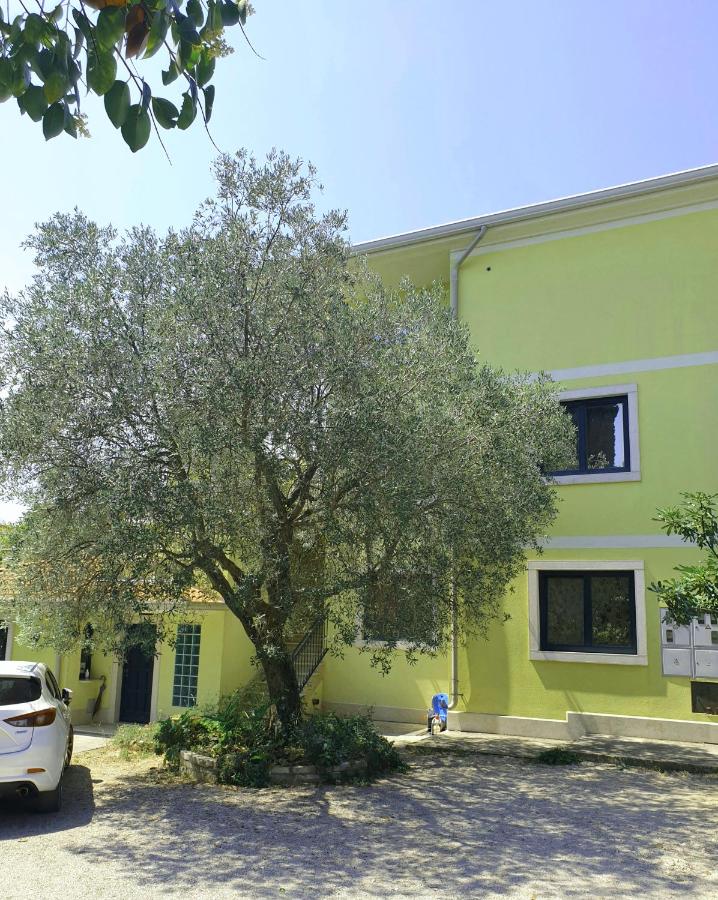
left=661, top=610, right=718, bottom=679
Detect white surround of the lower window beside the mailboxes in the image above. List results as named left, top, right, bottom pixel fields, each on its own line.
left=527, top=559, right=648, bottom=666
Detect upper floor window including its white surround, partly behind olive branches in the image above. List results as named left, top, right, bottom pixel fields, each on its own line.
left=551, top=385, right=641, bottom=484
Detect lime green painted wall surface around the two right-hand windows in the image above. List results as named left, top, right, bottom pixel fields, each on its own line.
left=324, top=184, right=718, bottom=721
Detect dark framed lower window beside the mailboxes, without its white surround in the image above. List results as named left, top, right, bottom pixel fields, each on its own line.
left=539, top=571, right=638, bottom=654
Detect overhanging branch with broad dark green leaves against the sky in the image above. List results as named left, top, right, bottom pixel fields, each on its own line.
left=0, top=0, right=251, bottom=153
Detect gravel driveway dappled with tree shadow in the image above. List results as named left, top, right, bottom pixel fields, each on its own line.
left=0, top=751, right=718, bottom=900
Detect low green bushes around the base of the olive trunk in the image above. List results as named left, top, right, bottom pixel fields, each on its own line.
left=155, top=692, right=405, bottom=787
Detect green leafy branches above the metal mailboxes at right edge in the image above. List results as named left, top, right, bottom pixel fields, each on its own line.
left=650, top=491, right=718, bottom=625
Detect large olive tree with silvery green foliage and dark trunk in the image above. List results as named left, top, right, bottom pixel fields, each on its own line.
left=0, top=152, right=571, bottom=719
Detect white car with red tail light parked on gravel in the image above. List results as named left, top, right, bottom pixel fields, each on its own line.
left=0, top=662, right=73, bottom=812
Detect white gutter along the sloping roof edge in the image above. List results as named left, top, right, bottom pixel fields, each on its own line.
left=352, top=165, right=718, bottom=253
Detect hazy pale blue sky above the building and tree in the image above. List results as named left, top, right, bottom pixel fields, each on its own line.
left=0, top=0, right=718, bottom=516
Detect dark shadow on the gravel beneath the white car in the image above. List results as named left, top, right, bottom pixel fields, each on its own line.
left=0, top=765, right=95, bottom=841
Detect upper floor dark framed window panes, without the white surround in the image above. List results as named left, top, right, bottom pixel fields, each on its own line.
left=551, top=394, right=631, bottom=475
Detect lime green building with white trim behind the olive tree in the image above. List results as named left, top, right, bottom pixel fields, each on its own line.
left=0, top=166, right=718, bottom=743
